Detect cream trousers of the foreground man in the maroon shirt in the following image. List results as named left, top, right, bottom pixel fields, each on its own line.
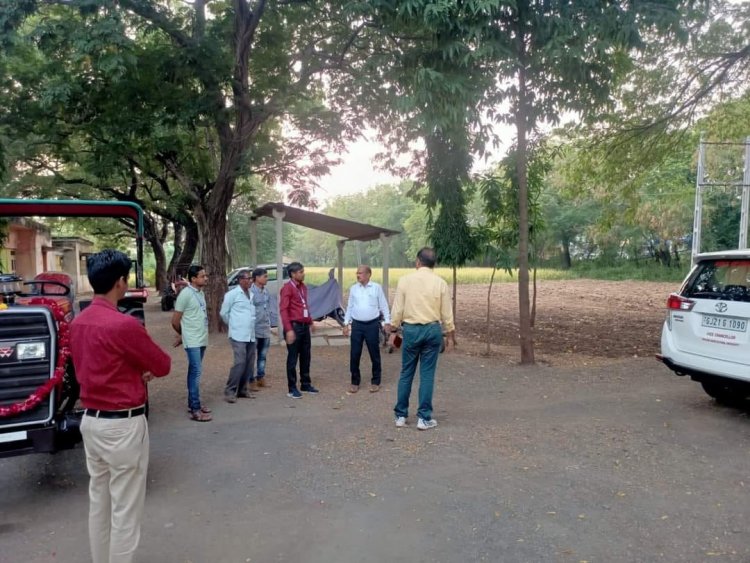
left=81, top=415, right=149, bottom=563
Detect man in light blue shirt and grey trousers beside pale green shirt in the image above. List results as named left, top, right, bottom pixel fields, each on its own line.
left=219, top=272, right=255, bottom=403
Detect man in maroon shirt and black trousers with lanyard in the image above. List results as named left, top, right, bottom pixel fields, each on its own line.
left=279, top=262, right=318, bottom=399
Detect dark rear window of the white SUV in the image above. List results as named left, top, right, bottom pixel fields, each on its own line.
left=685, top=260, right=750, bottom=302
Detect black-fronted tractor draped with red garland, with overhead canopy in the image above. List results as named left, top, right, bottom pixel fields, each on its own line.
left=0, top=199, right=148, bottom=457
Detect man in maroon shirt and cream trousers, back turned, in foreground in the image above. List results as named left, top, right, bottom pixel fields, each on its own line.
left=70, top=250, right=172, bottom=563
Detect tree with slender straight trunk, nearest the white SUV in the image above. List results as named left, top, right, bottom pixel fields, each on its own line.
left=482, top=0, right=704, bottom=364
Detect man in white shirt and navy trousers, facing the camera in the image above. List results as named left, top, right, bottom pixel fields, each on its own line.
left=344, top=264, right=391, bottom=393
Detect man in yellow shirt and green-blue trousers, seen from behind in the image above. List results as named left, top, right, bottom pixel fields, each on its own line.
left=391, top=247, right=456, bottom=430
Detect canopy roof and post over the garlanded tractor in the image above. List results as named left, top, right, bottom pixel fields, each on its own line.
left=0, top=199, right=145, bottom=289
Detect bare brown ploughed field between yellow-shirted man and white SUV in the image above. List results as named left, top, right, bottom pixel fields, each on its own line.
left=457, top=280, right=677, bottom=365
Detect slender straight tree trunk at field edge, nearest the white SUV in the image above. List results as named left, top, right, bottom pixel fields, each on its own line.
left=516, top=24, right=534, bottom=365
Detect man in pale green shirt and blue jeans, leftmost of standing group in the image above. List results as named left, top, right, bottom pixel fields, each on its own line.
left=172, top=264, right=211, bottom=422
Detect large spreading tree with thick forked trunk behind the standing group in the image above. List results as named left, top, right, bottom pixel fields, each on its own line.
left=0, top=0, right=356, bottom=329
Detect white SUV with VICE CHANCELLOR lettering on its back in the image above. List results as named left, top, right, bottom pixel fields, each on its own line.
left=657, top=250, right=750, bottom=404
